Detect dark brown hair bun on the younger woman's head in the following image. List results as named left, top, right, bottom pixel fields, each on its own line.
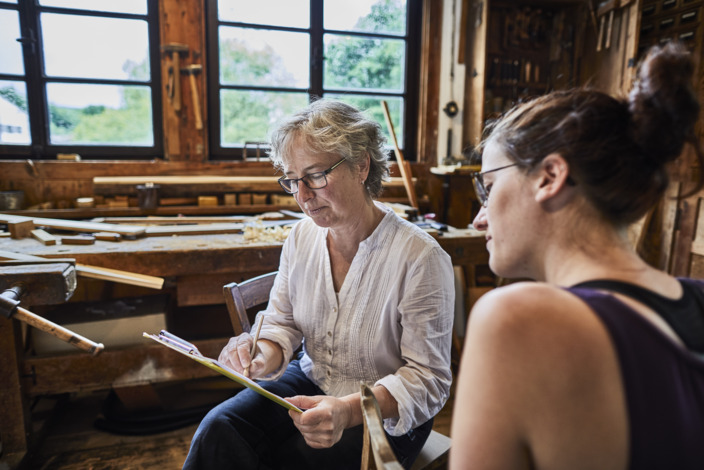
left=629, top=42, right=699, bottom=164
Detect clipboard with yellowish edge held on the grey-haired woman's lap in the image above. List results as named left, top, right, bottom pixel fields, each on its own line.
left=142, top=330, right=303, bottom=413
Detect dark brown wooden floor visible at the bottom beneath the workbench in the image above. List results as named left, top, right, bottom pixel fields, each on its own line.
left=23, top=378, right=453, bottom=470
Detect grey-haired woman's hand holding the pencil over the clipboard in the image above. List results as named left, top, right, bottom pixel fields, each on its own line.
left=218, top=333, right=283, bottom=379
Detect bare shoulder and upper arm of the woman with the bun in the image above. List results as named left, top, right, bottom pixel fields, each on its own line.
left=453, top=282, right=626, bottom=469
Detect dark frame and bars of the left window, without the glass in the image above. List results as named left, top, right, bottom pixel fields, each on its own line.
left=0, top=0, right=164, bottom=160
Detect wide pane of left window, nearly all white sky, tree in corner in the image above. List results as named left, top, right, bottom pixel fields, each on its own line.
left=41, top=13, right=150, bottom=81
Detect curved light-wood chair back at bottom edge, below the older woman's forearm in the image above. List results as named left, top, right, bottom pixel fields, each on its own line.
left=360, top=383, right=403, bottom=470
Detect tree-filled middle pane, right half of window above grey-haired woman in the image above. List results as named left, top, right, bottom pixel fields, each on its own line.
left=323, top=34, right=406, bottom=92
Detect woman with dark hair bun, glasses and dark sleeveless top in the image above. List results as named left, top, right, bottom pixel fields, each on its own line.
left=450, top=43, right=704, bottom=470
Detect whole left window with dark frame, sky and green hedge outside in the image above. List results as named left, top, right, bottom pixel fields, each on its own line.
left=0, top=0, right=162, bottom=158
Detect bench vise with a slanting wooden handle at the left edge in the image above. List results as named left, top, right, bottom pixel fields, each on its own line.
left=0, top=259, right=104, bottom=356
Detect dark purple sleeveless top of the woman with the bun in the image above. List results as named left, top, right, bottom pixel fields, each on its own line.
left=567, top=279, right=704, bottom=470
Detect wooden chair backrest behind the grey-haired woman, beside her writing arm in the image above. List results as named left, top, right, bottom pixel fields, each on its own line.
left=222, top=271, right=277, bottom=336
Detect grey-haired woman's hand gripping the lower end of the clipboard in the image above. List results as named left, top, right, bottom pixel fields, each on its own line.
left=286, top=395, right=359, bottom=449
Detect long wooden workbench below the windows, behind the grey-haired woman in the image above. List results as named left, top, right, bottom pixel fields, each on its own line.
left=0, top=227, right=488, bottom=464
